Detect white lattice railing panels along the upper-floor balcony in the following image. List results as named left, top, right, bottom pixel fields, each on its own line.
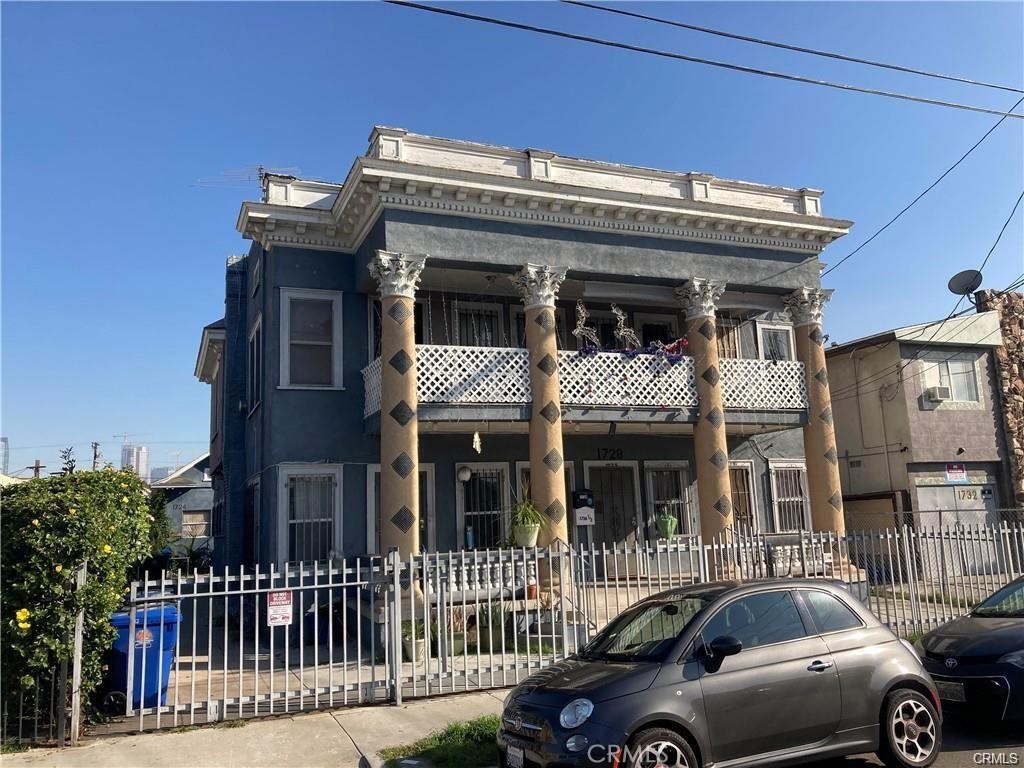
left=362, top=344, right=807, bottom=420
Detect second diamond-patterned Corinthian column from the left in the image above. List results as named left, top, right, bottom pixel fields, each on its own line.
left=512, top=264, right=568, bottom=546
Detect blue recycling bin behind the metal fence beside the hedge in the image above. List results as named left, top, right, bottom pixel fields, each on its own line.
left=110, top=602, right=181, bottom=710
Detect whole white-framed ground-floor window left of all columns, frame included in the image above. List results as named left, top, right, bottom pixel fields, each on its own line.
left=279, top=464, right=342, bottom=562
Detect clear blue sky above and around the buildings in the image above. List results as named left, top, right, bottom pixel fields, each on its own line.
left=0, top=2, right=1024, bottom=469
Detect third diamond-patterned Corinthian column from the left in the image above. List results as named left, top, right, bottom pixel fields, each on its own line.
left=676, top=278, right=732, bottom=544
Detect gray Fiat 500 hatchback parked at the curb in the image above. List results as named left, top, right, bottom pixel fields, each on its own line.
left=498, top=580, right=942, bottom=768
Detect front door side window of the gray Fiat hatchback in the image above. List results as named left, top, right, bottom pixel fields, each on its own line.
left=700, top=591, right=807, bottom=650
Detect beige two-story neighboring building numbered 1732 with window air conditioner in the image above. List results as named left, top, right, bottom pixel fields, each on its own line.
left=826, top=311, right=1021, bottom=530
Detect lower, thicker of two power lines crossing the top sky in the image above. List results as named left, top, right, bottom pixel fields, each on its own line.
left=383, top=0, right=1024, bottom=119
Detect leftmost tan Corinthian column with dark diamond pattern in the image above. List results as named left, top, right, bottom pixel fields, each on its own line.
left=367, top=251, right=426, bottom=555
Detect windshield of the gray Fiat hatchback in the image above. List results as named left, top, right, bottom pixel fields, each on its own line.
left=578, top=595, right=715, bottom=662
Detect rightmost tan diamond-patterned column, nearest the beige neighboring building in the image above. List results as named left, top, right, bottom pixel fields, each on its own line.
left=783, top=288, right=846, bottom=534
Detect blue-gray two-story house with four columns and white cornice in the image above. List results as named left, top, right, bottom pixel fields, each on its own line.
left=196, top=127, right=851, bottom=563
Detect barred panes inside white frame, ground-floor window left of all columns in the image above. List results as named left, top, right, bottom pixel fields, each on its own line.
left=287, top=473, right=336, bottom=562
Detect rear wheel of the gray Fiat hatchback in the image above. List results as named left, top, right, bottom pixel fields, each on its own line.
left=878, top=688, right=942, bottom=768
